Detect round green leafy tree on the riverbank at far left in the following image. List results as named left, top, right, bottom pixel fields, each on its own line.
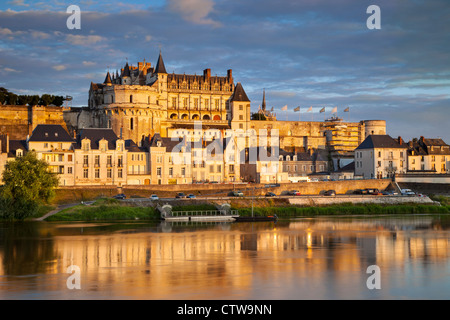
left=0, top=152, right=59, bottom=219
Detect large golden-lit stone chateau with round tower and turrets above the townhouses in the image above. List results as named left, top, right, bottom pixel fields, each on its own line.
left=85, top=53, right=386, bottom=168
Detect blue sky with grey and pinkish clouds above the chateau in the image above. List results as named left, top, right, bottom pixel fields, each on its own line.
left=0, top=0, right=450, bottom=144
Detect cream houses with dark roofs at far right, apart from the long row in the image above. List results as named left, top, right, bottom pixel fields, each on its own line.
left=354, top=135, right=450, bottom=179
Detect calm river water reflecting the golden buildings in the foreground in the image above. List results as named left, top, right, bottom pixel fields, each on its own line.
left=0, top=215, right=450, bottom=300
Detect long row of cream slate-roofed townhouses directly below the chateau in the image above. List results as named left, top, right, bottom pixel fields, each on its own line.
left=0, top=125, right=338, bottom=186
